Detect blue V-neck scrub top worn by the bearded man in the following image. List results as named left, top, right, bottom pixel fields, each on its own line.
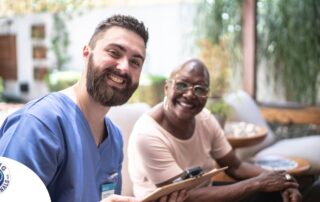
left=0, top=93, right=123, bottom=202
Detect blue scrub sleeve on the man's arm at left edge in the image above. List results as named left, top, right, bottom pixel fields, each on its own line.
left=0, top=114, right=62, bottom=185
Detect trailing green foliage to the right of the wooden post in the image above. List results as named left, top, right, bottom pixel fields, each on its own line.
left=257, top=0, right=320, bottom=104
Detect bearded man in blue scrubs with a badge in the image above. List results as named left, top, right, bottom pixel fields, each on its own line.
left=0, top=15, right=186, bottom=202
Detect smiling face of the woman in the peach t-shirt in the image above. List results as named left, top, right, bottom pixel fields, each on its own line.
left=165, top=60, right=209, bottom=120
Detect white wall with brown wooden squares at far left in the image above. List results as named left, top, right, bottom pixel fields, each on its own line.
left=0, top=14, right=52, bottom=100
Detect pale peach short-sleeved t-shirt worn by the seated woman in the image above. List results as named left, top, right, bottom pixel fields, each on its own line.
left=128, top=109, right=231, bottom=197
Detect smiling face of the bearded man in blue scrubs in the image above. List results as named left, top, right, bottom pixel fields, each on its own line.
left=83, top=26, right=145, bottom=106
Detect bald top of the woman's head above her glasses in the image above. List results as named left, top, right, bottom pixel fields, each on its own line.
left=169, top=59, right=210, bottom=85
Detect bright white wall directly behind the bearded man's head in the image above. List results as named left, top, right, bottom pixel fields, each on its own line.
left=67, top=3, right=195, bottom=75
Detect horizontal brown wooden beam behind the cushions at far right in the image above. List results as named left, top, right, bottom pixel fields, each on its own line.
left=260, top=107, right=320, bottom=125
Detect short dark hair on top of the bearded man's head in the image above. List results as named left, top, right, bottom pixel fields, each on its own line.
left=89, top=14, right=149, bottom=47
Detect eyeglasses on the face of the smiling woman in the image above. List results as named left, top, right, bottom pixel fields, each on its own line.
left=169, top=80, right=209, bottom=97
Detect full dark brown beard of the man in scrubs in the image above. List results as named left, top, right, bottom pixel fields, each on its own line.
left=86, top=54, right=139, bottom=107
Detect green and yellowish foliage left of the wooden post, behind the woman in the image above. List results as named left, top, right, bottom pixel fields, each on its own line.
left=195, top=0, right=241, bottom=97
